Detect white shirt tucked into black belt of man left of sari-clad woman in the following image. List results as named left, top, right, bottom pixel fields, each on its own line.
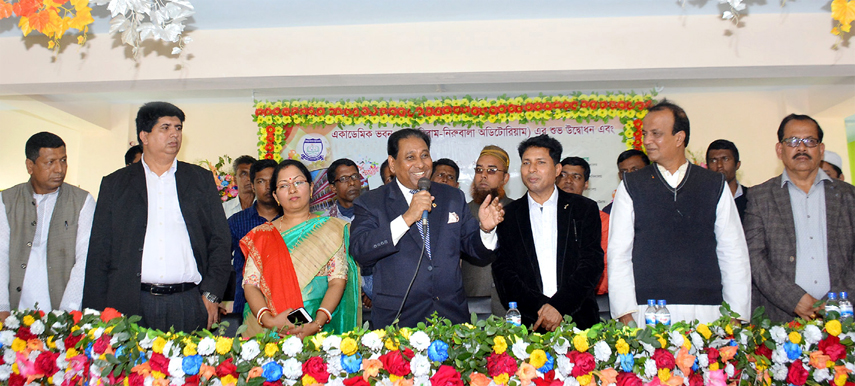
left=140, top=156, right=202, bottom=284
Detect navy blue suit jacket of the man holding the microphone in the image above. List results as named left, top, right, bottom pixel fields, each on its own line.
left=350, top=182, right=494, bottom=328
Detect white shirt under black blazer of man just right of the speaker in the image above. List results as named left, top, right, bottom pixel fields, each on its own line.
left=526, top=186, right=558, bottom=297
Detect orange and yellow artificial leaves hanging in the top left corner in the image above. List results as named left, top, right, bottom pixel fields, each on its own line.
left=0, top=0, right=95, bottom=50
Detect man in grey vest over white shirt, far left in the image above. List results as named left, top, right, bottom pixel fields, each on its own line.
left=0, top=132, right=95, bottom=320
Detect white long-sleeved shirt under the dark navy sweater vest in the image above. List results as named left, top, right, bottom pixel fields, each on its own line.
left=608, top=163, right=751, bottom=326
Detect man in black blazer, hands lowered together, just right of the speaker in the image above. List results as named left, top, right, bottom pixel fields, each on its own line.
left=493, top=134, right=604, bottom=331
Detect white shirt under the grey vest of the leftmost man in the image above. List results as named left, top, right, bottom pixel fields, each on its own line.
left=0, top=185, right=95, bottom=311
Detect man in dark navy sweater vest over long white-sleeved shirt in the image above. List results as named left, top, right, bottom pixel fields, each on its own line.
left=608, top=100, right=751, bottom=325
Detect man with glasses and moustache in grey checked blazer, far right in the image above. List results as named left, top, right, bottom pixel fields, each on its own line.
left=745, top=114, right=855, bottom=321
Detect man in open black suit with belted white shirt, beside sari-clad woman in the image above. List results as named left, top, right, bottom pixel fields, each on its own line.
left=83, top=102, right=231, bottom=332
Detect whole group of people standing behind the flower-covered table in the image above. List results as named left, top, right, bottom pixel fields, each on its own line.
left=0, top=100, right=855, bottom=338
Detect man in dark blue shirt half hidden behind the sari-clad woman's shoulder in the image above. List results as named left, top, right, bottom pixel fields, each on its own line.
left=229, top=159, right=282, bottom=322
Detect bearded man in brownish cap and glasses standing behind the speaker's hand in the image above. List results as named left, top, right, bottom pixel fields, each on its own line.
left=461, top=145, right=513, bottom=316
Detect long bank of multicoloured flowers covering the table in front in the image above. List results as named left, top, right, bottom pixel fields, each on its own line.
left=0, top=305, right=855, bottom=386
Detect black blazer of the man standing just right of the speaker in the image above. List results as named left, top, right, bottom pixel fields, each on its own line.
left=493, top=188, right=604, bottom=329
